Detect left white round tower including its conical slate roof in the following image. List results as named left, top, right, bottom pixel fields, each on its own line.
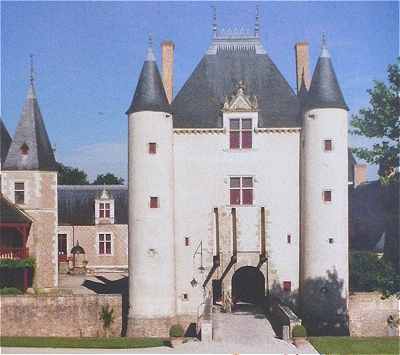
left=127, top=39, right=176, bottom=336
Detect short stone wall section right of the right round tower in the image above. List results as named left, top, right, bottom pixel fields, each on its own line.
left=349, top=292, right=400, bottom=336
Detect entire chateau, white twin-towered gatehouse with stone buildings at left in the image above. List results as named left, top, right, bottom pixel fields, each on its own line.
left=1, top=20, right=348, bottom=336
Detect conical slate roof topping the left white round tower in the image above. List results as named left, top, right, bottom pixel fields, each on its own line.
left=126, top=47, right=171, bottom=115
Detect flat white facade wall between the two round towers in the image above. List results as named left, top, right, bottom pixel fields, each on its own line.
left=174, top=126, right=299, bottom=314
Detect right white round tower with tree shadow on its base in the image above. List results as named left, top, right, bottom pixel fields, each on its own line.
left=301, top=37, right=348, bottom=331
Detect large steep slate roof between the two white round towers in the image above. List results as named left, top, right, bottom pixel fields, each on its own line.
left=172, top=38, right=301, bottom=128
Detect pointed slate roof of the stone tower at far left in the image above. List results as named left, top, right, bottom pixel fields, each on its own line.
left=2, top=81, right=57, bottom=171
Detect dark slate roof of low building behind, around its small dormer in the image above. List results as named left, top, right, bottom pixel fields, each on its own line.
left=58, top=185, right=128, bottom=226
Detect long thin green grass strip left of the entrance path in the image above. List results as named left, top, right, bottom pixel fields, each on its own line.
left=0, top=337, right=169, bottom=349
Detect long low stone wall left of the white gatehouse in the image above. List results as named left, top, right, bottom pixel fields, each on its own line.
left=0, top=295, right=122, bottom=337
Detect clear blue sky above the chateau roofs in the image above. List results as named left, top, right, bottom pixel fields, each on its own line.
left=1, top=1, right=399, bottom=182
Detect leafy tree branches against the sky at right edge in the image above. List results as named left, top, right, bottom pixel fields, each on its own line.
left=351, top=57, right=400, bottom=184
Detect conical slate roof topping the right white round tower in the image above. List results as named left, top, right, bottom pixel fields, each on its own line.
left=307, top=44, right=348, bottom=110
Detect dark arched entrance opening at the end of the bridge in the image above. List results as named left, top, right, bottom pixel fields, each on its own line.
left=232, top=266, right=265, bottom=304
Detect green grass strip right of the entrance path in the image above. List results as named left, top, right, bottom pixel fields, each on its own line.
left=308, top=337, right=400, bottom=354
